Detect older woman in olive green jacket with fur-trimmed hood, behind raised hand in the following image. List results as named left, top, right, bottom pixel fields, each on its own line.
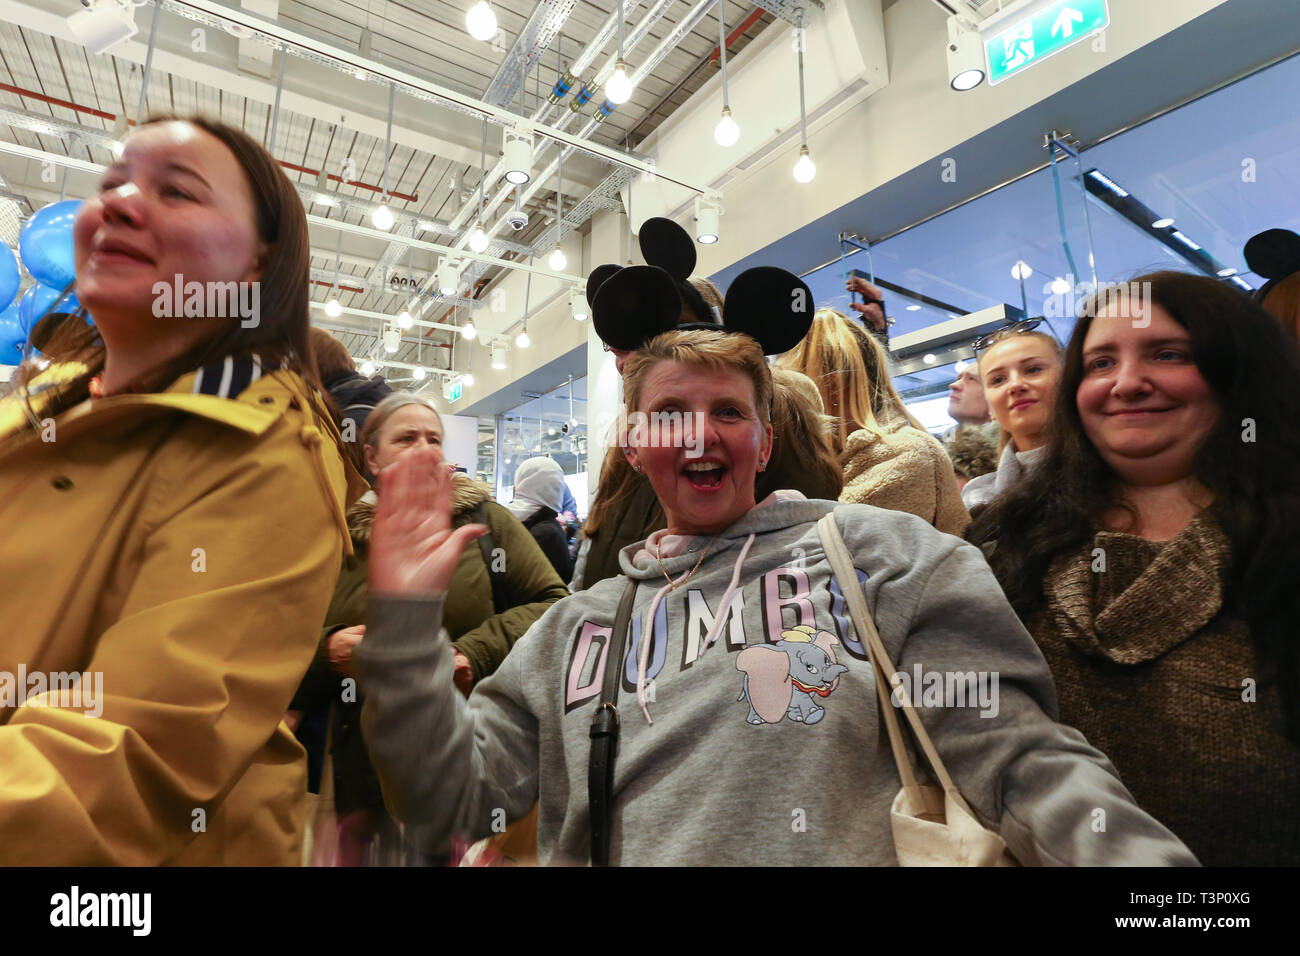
left=293, top=393, right=568, bottom=864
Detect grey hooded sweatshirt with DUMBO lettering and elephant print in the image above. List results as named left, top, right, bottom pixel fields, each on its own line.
left=355, top=493, right=1196, bottom=865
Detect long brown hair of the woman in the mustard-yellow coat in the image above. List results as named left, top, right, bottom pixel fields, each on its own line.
left=18, top=114, right=329, bottom=407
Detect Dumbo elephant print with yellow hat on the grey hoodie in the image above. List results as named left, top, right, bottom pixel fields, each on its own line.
left=736, top=624, right=849, bottom=724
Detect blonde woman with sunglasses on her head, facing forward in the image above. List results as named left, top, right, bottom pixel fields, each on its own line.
left=962, top=319, right=1061, bottom=509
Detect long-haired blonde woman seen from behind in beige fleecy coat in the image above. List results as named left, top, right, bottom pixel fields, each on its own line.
left=780, top=308, right=970, bottom=535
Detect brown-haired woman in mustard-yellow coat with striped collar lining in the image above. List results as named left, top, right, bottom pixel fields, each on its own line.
left=0, top=120, right=361, bottom=866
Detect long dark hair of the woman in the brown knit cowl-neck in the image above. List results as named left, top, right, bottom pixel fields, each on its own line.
left=966, top=272, right=1300, bottom=743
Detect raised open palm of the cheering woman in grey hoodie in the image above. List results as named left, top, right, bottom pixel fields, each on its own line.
left=369, top=446, right=488, bottom=597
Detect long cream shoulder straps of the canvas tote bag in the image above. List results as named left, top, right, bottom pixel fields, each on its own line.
left=818, top=511, right=975, bottom=817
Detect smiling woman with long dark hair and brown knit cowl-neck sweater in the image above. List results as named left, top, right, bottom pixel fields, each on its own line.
left=969, top=272, right=1300, bottom=865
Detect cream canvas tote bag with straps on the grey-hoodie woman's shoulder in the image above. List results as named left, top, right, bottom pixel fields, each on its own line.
left=818, top=512, right=1018, bottom=866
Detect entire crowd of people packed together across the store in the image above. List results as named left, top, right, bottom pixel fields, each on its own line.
left=0, top=117, right=1300, bottom=865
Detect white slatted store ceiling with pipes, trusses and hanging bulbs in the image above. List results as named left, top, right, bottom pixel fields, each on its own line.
left=0, top=0, right=776, bottom=384
